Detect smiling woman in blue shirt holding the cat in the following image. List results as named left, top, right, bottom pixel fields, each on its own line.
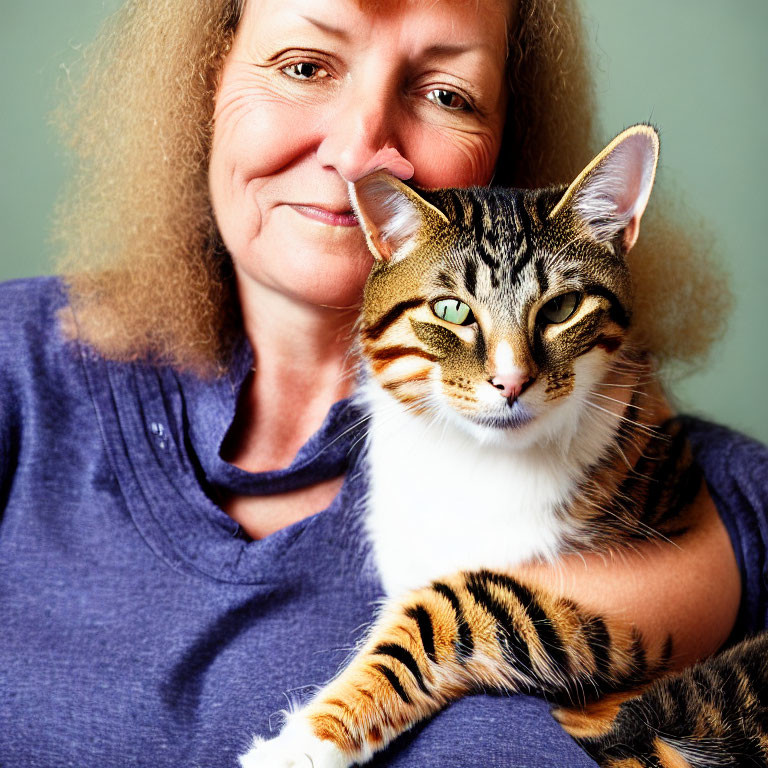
left=0, top=0, right=764, bottom=766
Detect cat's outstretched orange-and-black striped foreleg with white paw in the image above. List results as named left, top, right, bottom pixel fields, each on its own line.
left=241, top=571, right=668, bottom=768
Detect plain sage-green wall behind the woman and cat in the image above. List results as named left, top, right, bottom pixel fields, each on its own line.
left=0, top=0, right=768, bottom=442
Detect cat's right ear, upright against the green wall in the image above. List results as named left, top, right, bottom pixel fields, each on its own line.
left=549, top=125, right=659, bottom=253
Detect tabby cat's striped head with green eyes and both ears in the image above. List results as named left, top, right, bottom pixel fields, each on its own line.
left=351, top=125, right=659, bottom=442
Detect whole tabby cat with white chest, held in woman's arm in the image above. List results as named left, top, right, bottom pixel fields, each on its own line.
left=241, top=125, right=768, bottom=768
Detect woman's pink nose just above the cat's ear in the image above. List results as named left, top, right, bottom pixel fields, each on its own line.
left=317, top=91, right=413, bottom=181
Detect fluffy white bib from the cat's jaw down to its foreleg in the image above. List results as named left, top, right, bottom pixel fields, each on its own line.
left=361, top=351, right=619, bottom=594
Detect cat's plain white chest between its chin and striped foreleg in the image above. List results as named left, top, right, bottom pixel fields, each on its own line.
left=367, top=400, right=576, bottom=594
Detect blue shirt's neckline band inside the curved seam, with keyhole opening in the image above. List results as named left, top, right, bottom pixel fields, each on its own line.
left=81, top=340, right=366, bottom=584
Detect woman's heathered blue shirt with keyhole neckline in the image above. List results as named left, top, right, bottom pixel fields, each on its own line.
left=0, top=279, right=768, bottom=768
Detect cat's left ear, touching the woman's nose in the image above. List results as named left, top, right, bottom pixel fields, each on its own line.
left=349, top=171, right=448, bottom=262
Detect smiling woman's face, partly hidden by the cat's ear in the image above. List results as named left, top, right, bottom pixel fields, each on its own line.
left=209, top=0, right=507, bottom=306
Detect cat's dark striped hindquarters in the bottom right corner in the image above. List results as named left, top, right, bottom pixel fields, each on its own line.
left=553, top=633, right=768, bottom=768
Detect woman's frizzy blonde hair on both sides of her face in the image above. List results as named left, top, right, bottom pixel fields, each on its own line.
left=54, top=0, right=728, bottom=374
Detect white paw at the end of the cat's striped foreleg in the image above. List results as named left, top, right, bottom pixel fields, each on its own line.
left=240, top=720, right=352, bottom=768
